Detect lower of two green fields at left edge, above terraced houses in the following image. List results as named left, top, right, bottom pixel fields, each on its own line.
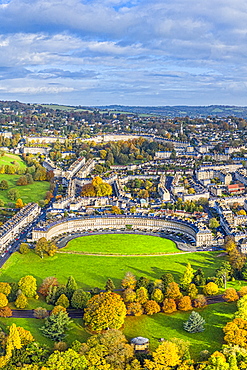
left=0, top=174, right=50, bottom=204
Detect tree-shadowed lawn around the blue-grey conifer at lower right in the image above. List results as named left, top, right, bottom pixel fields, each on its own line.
left=124, top=303, right=236, bottom=359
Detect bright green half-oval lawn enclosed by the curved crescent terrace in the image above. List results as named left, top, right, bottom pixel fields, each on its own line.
left=63, top=234, right=179, bottom=254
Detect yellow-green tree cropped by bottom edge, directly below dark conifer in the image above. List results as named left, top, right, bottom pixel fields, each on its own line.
left=45, top=348, right=87, bottom=370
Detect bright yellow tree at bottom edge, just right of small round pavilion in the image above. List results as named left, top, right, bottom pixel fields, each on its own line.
left=144, top=341, right=180, bottom=370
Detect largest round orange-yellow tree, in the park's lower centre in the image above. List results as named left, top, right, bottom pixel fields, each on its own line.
left=84, top=292, right=126, bottom=331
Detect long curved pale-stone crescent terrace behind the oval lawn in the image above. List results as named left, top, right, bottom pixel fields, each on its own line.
left=32, top=216, right=212, bottom=246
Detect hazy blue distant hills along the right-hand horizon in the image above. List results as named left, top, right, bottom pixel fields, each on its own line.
left=92, top=105, right=247, bottom=118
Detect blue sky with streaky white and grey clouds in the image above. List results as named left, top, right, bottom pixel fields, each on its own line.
left=0, top=0, right=247, bottom=105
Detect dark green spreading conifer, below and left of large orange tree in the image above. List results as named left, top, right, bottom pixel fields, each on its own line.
left=40, top=312, right=71, bottom=342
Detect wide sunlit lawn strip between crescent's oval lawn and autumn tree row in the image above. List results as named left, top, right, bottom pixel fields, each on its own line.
left=1, top=251, right=224, bottom=289
